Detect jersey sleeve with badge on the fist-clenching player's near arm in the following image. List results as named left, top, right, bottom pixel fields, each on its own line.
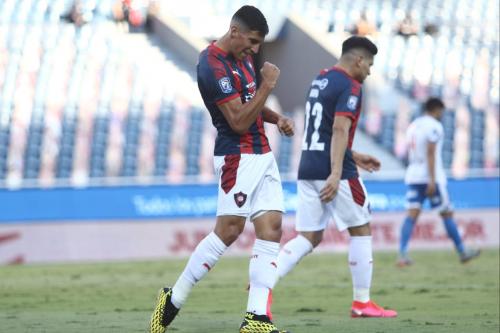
left=205, top=57, right=240, bottom=105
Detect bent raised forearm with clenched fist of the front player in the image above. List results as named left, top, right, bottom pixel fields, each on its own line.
left=219, top=62, right=280, bottom=135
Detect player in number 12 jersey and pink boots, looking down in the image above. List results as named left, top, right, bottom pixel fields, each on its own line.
left=278, top=36, right=397, bottom=318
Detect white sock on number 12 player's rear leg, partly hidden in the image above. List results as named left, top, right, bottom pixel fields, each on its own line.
left=278, top=234, right=313, bottom=279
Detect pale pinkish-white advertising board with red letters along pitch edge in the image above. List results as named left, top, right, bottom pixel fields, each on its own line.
left=0, top=209, right=500, bottom=264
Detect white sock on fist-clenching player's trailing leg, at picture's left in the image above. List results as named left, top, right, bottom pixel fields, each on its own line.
left=172, top=231, right=227, bottom=309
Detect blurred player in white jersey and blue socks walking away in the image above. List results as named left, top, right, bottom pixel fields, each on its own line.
left=397, top=97, right=480, bottom=267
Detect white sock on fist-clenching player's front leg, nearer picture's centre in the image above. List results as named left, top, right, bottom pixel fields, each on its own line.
left=247, top=239, right=280, bottom=317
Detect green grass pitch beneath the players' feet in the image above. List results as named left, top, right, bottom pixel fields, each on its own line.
left=0, top=249, right=500, bottom=333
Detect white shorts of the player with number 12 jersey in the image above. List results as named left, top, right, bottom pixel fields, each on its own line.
left=295, top=178, right=371, bottom=231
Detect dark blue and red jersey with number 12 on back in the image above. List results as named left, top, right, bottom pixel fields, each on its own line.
left=298, top=67, right=362, bottom=180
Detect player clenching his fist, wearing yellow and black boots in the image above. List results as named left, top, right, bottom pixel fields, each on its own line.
left=151, top=6, right=294, bottom=333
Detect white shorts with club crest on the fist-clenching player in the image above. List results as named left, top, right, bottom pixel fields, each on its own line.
left=214, top=152, right=284, bottom=220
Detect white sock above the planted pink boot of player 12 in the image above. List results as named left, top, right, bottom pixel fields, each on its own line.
left=349, top=236, right=373, bottom=303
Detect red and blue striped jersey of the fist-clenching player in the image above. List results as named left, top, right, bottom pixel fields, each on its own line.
left=197, top=42, right=271, bottom=156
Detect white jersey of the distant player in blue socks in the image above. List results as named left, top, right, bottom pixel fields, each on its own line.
left=405, top=115, right=446, bottom=184
